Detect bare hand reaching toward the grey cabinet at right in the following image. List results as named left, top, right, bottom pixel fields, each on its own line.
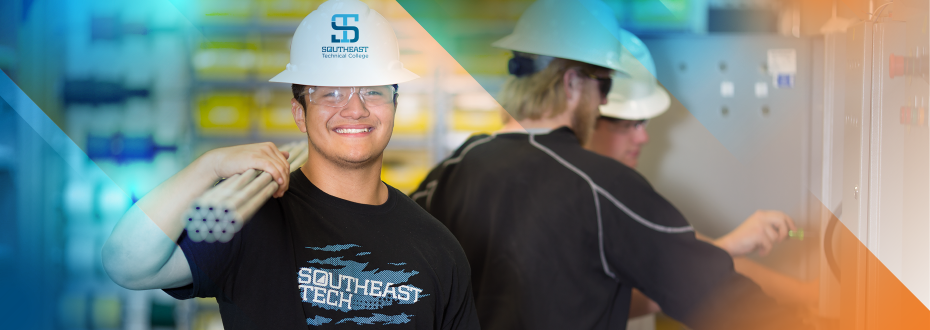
left=714, top=210, right=796, bottom=257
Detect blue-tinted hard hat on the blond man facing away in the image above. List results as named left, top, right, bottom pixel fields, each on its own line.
left=492, top=0, right=622, bottom=70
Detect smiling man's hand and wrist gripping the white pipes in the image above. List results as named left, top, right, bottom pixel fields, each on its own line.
left=201, top=142, right=291, bottom=197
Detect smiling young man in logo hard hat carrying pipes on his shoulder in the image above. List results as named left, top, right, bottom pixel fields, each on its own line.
left=103, top=0, right=478, bottom=329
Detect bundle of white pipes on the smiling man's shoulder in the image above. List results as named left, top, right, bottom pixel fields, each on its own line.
left=184, top=142, right=307, bottom=243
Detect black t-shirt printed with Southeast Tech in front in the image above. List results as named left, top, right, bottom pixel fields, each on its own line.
left=165, top=171, right=478, bottom=329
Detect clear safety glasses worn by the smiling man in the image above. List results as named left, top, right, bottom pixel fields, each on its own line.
left=300, top=85, right=397, bottom=108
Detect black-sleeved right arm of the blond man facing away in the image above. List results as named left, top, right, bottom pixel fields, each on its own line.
left=604, top=192, right=804, bottom=330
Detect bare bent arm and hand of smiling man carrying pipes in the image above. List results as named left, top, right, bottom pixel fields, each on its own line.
left=102, top=142, right=290, bottom=290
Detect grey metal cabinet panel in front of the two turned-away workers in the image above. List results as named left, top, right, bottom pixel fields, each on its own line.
left=638, top=35, right=822, bottom=279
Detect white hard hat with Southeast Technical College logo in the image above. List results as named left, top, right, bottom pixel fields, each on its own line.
left=269, top=0, right=418, bottom=86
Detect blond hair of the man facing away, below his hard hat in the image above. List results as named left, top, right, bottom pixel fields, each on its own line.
left=498, top=58, right=605, bottom=121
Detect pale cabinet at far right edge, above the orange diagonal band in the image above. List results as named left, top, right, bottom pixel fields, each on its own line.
left=837, top=17, right=930, bottom=305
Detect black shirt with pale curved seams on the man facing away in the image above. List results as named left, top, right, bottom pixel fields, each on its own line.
left=411, top=128, right=797, bottom=330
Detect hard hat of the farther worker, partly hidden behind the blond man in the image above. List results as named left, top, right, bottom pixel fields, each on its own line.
left=601, top=29, right=672, bottom=120
